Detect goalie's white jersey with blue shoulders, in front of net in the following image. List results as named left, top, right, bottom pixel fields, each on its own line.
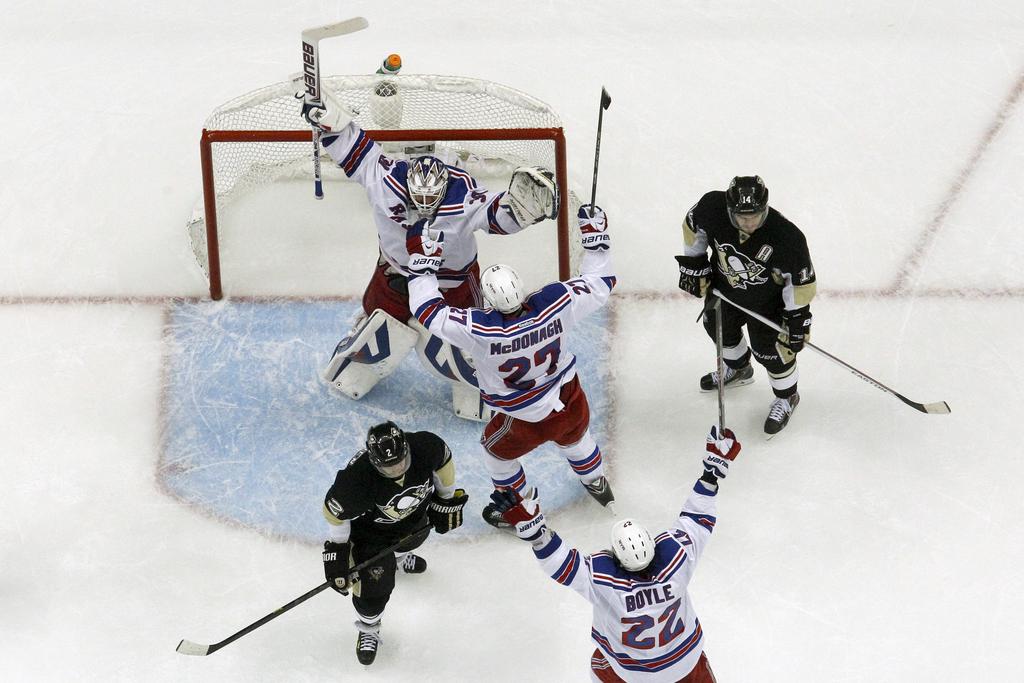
left=324, top=123, right=522, bottom=289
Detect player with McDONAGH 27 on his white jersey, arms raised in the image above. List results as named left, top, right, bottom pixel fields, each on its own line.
left=409, top=207, right=615, bottom=527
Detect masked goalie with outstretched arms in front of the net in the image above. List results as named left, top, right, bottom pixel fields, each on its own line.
left=302, top=80, right=558, bottom=419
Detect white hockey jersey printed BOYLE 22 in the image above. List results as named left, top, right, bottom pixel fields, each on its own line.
left=534, top=480, right=716, bottom=683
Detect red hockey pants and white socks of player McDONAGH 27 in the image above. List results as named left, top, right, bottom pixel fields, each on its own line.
left=480, top=377, right=604, bottom=493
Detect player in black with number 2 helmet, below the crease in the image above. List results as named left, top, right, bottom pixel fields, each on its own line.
left=323, top=422, right=469, bottom=665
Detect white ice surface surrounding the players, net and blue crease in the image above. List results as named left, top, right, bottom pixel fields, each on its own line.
left=0, top=0, right=1024, bottom=683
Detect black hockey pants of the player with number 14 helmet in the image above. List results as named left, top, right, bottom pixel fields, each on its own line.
left=703, top=301, right=800, bottom=398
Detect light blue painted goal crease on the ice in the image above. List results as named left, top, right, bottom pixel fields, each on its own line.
left=160, top=301, right=613, bottom=543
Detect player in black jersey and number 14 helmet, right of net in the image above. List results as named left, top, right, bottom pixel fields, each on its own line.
left=676, top=175, right=816, bottom=434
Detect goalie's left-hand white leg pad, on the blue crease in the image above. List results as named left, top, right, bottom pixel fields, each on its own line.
left=321, top=308, right=419, bottom=399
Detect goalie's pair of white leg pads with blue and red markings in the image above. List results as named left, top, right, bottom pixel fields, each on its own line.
left=321, top=308, right=492, bottom=422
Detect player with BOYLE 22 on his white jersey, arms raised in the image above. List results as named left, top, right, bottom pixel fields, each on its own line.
left=492, top=427, right=739, bottom=683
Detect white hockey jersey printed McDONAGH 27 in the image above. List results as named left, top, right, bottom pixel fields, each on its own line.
left=409, top=248, right=615, bottom=422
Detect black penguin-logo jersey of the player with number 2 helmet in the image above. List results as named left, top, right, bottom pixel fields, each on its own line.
left=324, top=431, right=454, bottom=539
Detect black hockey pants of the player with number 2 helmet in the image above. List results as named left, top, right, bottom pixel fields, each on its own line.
left=351, top=517, right=430, bottom=624
